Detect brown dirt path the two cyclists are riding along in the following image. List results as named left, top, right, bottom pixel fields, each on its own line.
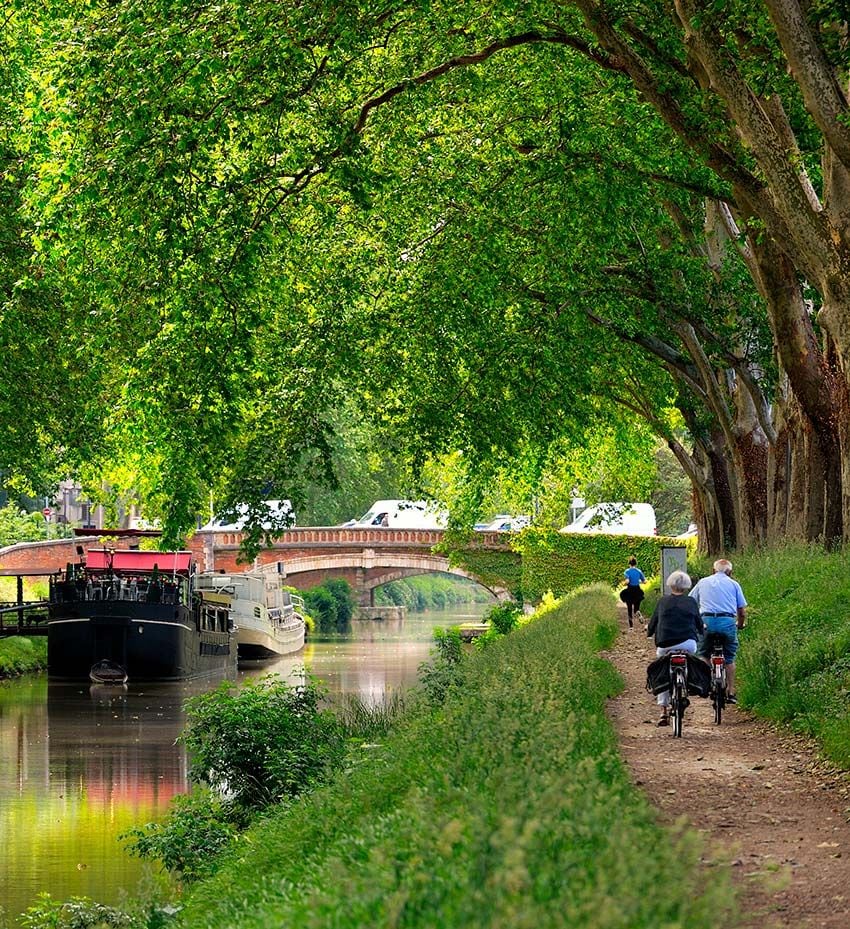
left=609, top=611, right=850, bottom=929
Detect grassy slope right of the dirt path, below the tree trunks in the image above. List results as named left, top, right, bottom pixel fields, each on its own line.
left=699, top=546, right=850, bottom=770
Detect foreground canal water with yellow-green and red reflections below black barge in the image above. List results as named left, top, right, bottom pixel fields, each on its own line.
left=0, top=677, right=209, bottom=923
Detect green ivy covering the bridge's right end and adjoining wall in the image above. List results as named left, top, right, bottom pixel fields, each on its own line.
left=440, top=528, right=694, bottom=603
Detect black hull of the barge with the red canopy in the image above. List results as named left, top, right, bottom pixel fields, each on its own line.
left=47, top=601, right=236, bottom=681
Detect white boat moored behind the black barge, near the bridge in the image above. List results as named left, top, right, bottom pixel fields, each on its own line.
left=198, top=572, right=305, bottom=660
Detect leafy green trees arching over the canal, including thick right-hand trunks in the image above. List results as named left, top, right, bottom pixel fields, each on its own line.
left=0, top=0, right=850, bottom=548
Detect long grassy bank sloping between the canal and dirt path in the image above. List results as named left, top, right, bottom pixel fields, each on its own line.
left=174, top=588, right=729, bottom=929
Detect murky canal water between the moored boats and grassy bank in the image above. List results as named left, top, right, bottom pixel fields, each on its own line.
left=0, top=604, right=486, bottom=929
